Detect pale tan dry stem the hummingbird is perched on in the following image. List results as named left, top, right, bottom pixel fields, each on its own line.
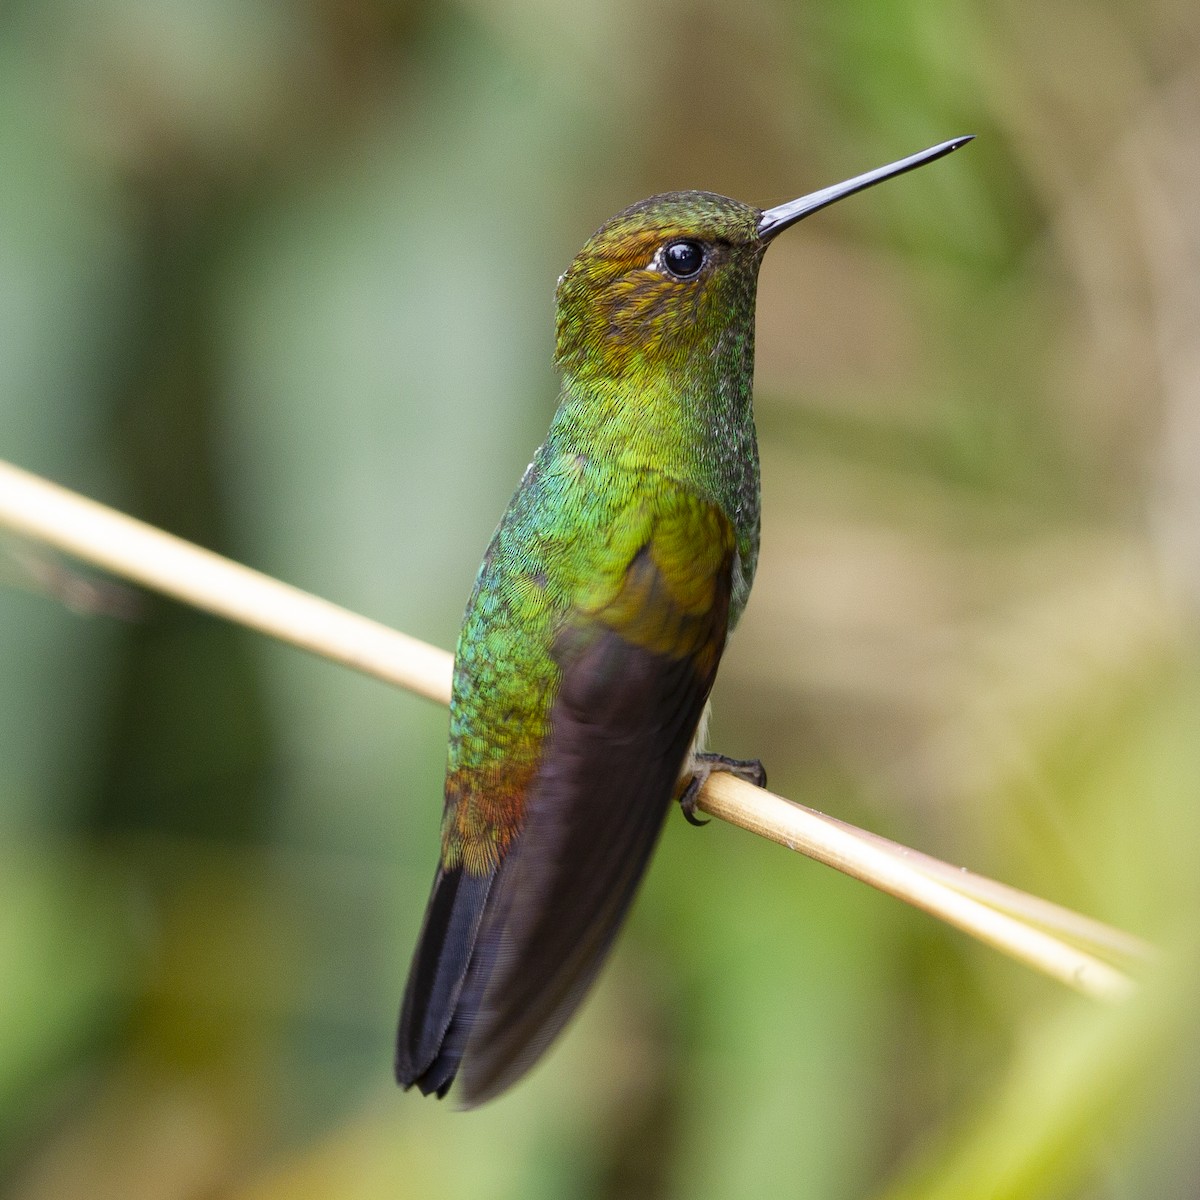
left=0, top=462, right=1151, bottom=1000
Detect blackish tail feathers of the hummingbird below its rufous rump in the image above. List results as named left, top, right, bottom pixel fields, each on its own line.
left=396, top=866, right=496, bottom=1097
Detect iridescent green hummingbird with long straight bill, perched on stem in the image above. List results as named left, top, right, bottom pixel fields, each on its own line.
left=396, top=137, right=971, bottom=1106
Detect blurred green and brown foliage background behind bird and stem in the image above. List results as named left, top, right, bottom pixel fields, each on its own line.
left=0, top=0, right=1200, bottom=1200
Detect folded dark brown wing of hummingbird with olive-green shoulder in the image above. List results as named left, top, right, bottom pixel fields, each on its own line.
left=462, top=477, right=734, bottom=1104
